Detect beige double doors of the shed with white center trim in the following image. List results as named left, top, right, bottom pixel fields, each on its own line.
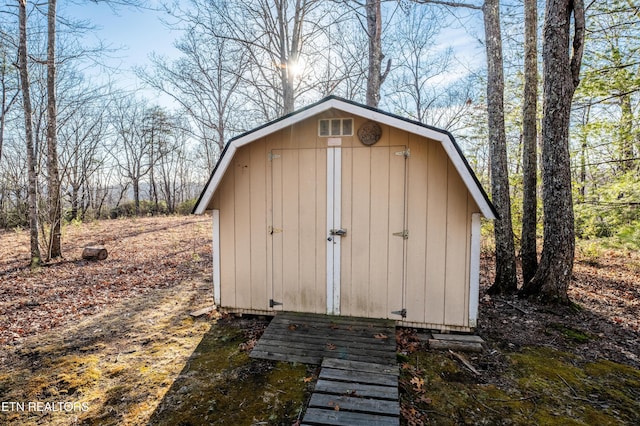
left=269, top=146, right=407, bottom=319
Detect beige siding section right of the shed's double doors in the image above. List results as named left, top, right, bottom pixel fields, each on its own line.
left=405, top=135, right=477, bottom=327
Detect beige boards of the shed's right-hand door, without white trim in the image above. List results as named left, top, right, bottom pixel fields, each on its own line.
left=340, top=145, right=406, bottom=318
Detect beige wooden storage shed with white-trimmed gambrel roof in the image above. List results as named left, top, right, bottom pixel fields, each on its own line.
left=194, top=96, right=495, bottom=331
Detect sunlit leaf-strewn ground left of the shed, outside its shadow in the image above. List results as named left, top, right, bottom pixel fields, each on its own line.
left=0, top=217, right=218, bottom=424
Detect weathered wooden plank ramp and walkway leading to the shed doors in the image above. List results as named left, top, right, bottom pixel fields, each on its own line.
left=250, top=312, right=400, bottom=426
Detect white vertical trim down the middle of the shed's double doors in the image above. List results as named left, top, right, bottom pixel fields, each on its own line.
left=327, top=147, right=342, bottom=315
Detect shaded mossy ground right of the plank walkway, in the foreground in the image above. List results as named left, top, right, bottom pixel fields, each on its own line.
left=400, top=347, right=640, bottom=425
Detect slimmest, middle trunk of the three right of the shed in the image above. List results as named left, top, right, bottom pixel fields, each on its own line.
left=520, top=0, right=538, bottom=282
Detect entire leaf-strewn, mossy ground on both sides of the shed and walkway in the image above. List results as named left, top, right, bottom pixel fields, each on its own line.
left=0, top=217, right=640, bottom=425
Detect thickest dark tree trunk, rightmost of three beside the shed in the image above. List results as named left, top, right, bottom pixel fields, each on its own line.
left=522, top=0, right=585, bottom=304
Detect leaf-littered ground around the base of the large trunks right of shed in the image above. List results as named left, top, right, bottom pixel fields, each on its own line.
left=477, top=246, right=640, bottom=368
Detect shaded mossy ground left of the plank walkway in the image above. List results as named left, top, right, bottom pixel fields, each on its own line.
left=150, top=326, right=308, bottom=425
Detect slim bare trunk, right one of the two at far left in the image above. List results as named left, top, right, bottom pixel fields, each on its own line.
left=47, top=0, right=62, bottom=259
